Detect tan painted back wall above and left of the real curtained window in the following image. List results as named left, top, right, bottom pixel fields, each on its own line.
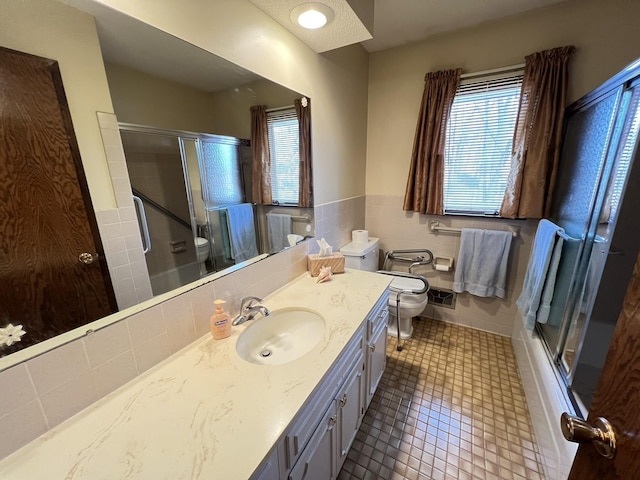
left=366, top=0, right=640, bottom=195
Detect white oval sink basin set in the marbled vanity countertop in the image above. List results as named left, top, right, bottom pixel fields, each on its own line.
left=236, top=308, right=325, bottom=365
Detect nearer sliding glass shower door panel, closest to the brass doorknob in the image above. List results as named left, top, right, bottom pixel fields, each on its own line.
left=560, top=83, right=640, bottom=413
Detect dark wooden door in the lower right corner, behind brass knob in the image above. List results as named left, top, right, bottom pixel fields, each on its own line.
left=558, top=251, right=640, bottom=480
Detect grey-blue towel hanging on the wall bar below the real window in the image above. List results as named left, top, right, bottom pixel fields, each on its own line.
left=453, top=228, right=513, bottom=298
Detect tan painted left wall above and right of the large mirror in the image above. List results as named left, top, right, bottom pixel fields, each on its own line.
left=84, top=0, right=368, bottom=204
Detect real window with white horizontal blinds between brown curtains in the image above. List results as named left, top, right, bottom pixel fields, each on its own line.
left=444, top=70, right=522, bottom=216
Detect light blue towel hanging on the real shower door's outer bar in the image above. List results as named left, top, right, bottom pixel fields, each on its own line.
left=516, top=219, right=564, bottom=329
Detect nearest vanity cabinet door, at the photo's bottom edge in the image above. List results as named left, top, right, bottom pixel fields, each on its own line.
left=289, top=402, right=338, bottom=480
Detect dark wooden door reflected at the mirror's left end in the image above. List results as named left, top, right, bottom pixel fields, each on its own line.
left=0, top=48, right=116, bottom=355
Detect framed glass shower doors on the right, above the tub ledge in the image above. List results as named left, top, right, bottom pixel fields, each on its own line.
left=537, top=63, right=640, bottom=418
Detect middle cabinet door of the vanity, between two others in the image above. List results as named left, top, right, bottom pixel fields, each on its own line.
left=336, top=359, right=365, bottom=469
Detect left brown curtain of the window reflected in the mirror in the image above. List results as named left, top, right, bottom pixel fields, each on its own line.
left=251, top=105, right=273, bottom=205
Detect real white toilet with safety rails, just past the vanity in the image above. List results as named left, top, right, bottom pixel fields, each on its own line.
left=340, top=237, right=429, bottom=339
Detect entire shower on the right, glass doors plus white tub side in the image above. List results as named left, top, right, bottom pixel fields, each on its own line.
left=512, top=58, right=640, bottom=478
